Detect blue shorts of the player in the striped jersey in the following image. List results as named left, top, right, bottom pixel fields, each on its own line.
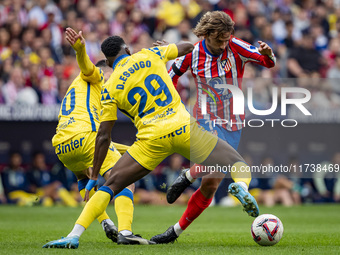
left=198, top=119, right=242, bottom=150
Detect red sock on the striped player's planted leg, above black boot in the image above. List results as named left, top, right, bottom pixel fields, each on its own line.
left=179, top=189, right=212, bottom=230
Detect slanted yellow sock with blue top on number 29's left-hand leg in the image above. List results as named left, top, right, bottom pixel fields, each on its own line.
left=76, top=186, right=113, bottom=229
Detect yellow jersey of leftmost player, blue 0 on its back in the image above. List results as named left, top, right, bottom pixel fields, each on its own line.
left=52, top=67, right=104, bottom=146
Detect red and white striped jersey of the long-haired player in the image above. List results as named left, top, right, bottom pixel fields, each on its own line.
left=169, top=36, right=276, bottom=131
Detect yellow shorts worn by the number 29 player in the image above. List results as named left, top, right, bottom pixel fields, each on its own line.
left=127, top=120, right=218, bottom=170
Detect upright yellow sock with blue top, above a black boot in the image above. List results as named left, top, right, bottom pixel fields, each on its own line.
left=115, top=188, right=134, bottom=232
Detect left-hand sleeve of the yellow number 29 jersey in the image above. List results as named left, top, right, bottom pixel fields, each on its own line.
left=100, top=86, right=118, bottom=122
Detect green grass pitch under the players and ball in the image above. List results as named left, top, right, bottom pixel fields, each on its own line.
left=0, top=205, right=340, bottom=255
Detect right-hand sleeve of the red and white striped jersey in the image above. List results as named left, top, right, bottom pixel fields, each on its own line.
left=231, top=37, right=276, bottom=68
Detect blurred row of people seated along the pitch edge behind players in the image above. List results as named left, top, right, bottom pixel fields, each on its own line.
left=0, top=151, right=340, bottom=207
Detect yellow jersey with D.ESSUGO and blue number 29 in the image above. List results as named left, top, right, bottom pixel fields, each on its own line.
left=100, top=44, right=190, bottom=139
